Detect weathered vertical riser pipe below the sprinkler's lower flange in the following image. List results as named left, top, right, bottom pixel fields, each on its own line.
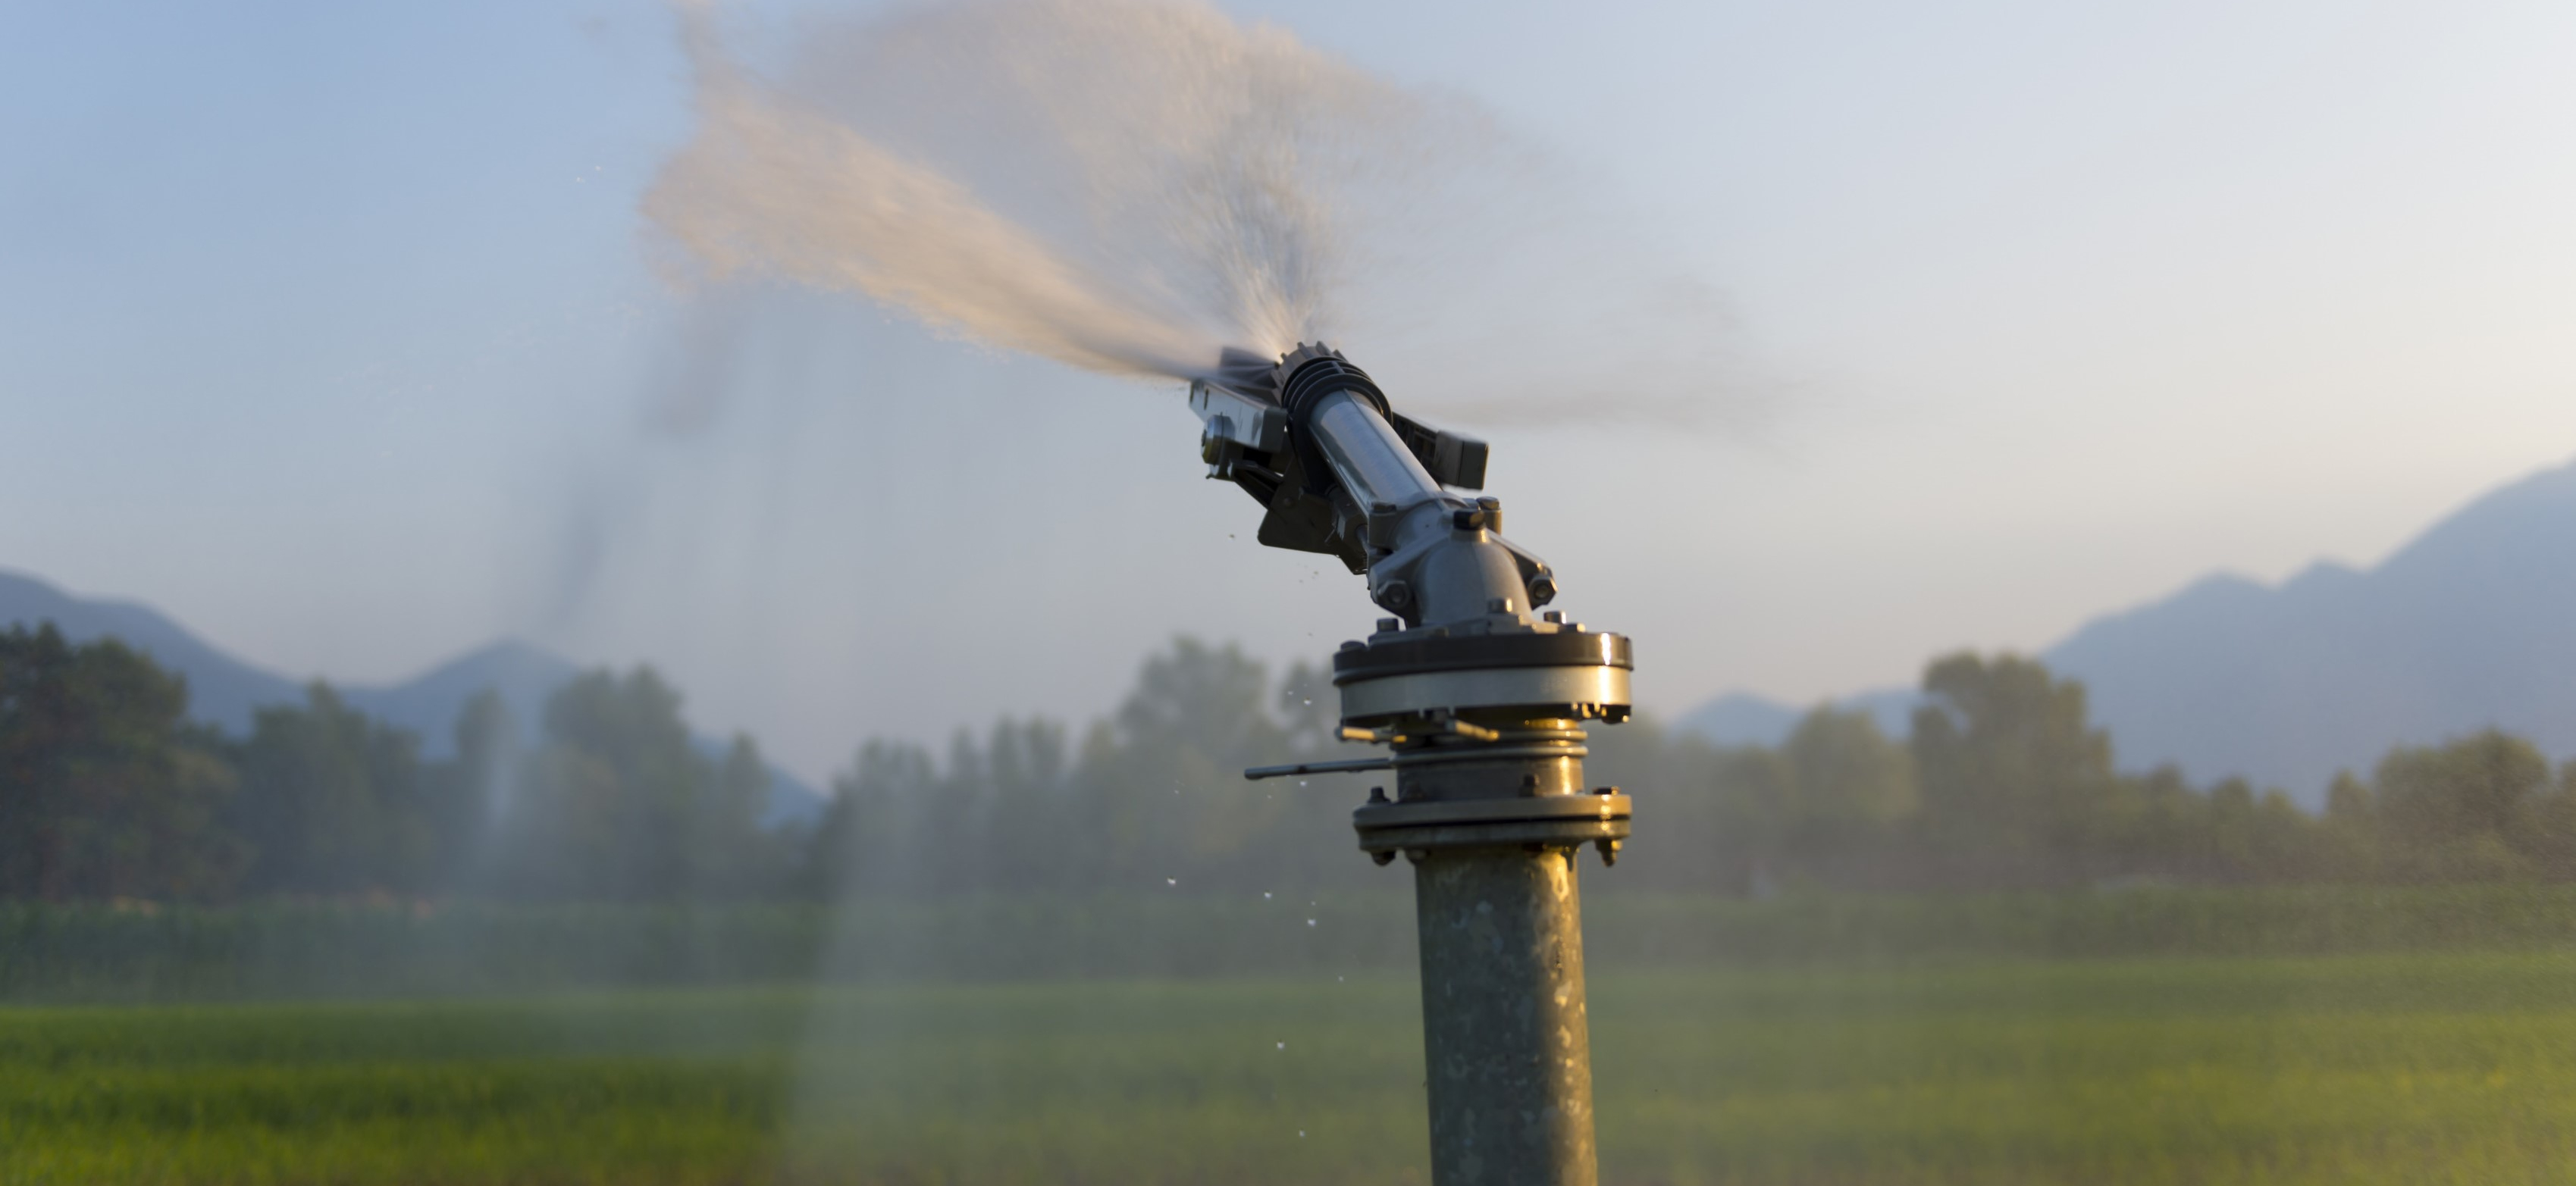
left=1415, top=846, right=1600, bottom=1186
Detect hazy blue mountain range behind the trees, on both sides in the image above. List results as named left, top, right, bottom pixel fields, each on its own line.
left=20, top=445, right=2576, bottom=821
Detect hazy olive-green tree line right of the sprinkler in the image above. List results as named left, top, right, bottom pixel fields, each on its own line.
left=1592, top=653, right=2576, bottom=893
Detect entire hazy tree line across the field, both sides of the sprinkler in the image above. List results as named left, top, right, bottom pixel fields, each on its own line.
left=0, top=615, right=2576, bottom=900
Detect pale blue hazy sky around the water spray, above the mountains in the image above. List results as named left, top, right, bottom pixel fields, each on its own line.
left=0, top=0, right=2576, bottom=774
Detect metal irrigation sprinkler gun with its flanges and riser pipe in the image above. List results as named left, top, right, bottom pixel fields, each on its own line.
left=1190, top=343, right=1631, bottom=1186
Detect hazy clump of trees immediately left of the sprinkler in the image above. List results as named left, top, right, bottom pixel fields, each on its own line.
left=801, top=638, right=1378, bottom=893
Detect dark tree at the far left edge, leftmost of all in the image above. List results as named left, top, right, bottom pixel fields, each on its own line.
left=0, top=623, right=245, bottom=900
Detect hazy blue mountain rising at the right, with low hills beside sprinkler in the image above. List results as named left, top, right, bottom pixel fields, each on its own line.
left=1682, top=452, right=2576, bottom=806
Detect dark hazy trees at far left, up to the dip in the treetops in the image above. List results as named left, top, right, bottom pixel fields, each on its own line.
left=0, top=623, right=801, bottom=900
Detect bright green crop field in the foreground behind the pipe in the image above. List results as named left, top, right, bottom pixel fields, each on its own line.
left=14, top=952, right=2576, bottom=1186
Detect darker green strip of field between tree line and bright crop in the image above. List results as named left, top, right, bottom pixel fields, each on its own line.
left=25, top=884, right=2576, bottom=1003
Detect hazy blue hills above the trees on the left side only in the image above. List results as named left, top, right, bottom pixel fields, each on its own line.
left=0, top=571, right=824, bottom=823
